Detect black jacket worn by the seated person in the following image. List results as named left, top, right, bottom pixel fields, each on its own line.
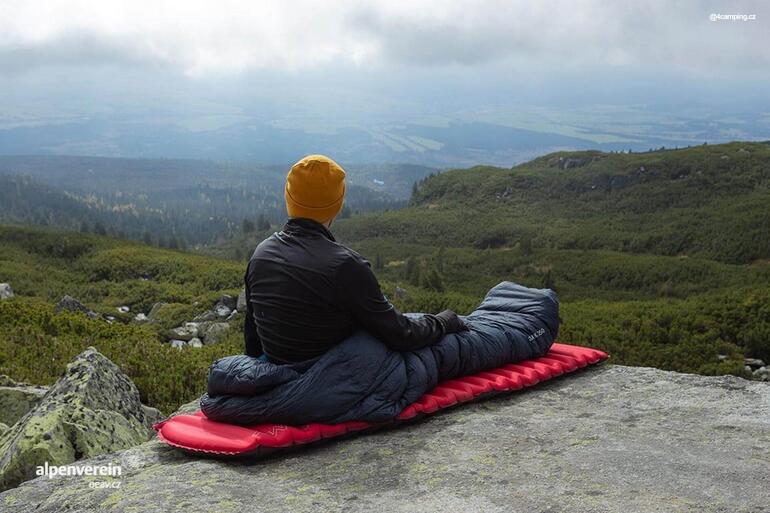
left=244, top=218, right=454, bottom=363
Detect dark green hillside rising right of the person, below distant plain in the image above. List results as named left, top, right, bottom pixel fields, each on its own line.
left=341, top=143, right=770, bottom=263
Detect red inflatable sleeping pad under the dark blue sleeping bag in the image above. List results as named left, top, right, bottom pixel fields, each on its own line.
left=153, top=343, right=609, bottom=456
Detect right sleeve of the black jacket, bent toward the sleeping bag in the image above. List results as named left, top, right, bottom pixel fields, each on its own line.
left=335, top=253, right=445, bottom=351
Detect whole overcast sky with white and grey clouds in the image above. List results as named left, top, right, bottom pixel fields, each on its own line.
left=0, top=0, right=770, bottom=123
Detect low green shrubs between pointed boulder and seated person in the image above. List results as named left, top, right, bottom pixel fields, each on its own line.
left=0, top=298, right=243, bottom=413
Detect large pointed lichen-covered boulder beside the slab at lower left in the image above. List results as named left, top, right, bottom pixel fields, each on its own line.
left=0, top=348, right=159, bottom=488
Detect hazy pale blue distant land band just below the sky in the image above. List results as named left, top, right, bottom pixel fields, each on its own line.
left=0, top=116, right=696, bottom=167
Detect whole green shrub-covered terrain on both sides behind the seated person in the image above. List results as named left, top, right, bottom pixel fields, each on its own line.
left=0, top=143, right=770, bottom=412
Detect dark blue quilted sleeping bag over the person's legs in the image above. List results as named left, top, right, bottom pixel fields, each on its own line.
left=201, top=282, right=559, bottom=425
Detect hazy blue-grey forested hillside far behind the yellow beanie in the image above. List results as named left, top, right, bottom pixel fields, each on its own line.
left=0, top=156, right=432, bottom=249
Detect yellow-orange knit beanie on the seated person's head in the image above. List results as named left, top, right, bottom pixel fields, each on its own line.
left=284, top=155, right=345, bottom=223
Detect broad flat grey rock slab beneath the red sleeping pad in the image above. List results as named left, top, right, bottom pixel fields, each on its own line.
left=0, top=366, right=770, bottom=513
